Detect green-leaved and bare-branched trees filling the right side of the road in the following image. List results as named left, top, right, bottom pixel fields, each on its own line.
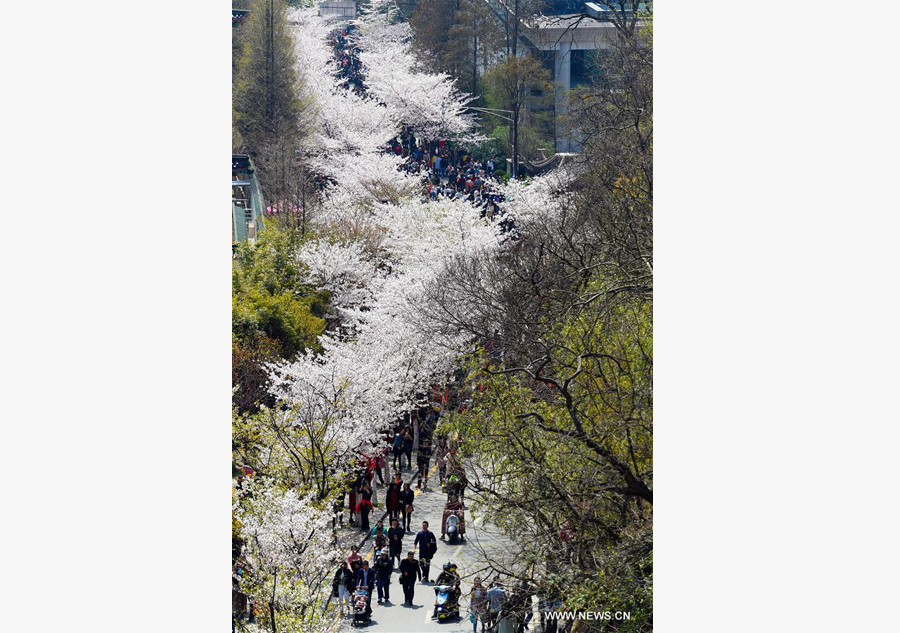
left=424, top=14, right=653, bottom=633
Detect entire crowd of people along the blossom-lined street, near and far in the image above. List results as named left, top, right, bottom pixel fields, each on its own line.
left=331, top=27, right=552, bottom=633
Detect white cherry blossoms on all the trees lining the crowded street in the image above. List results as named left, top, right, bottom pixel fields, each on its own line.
left=239, top=10, right=568, bottom=624
